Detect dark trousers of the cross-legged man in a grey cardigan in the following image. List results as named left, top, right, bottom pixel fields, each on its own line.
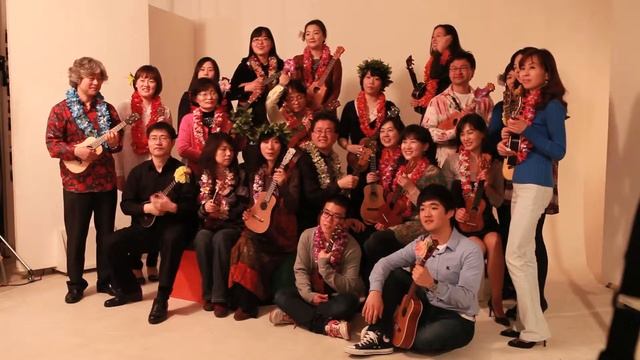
left=274, top=288, right=359, bottom=334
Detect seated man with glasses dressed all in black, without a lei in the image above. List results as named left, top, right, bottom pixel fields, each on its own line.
left=104, top=122, right=197, bottom=324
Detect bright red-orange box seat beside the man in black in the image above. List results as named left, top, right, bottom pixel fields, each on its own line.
left=171, top=250, right=204, bottom=304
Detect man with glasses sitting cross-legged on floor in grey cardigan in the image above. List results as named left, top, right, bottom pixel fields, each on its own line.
left=269, top=195, right=364, bottom=340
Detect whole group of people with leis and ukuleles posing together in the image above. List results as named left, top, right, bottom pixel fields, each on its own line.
left=46, top=20, right=567, bottom=355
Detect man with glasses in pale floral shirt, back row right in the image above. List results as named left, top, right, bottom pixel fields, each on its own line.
left=421, top=51, right=493, bottom=167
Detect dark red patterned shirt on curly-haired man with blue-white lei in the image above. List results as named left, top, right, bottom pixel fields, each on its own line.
left=46, top=100, right=122, bottom=193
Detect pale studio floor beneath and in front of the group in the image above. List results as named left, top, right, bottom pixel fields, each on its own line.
left=0, top=258, right=632, bottom=360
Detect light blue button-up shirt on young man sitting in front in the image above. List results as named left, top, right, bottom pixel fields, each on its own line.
left=369, top=229, right=484, bottom=316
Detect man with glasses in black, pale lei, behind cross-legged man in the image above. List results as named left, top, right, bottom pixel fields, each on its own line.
left=297, top=111, right=358, bottom=233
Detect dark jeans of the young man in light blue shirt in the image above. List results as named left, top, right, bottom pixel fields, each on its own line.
left=369, top=269, right=475, bottom=353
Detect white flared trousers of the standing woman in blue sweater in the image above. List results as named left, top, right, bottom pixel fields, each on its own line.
left=505, top=184, right=553, bottom=341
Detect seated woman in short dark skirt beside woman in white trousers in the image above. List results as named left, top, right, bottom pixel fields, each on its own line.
left=442, top=114, right=509, bottom=326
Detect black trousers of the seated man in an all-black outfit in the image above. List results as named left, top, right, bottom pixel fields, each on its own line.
left=105, top=218, right=188, bottom=300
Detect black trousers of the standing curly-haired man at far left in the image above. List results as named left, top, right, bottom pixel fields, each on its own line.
left=62, top=189, right=118, bottom=290
